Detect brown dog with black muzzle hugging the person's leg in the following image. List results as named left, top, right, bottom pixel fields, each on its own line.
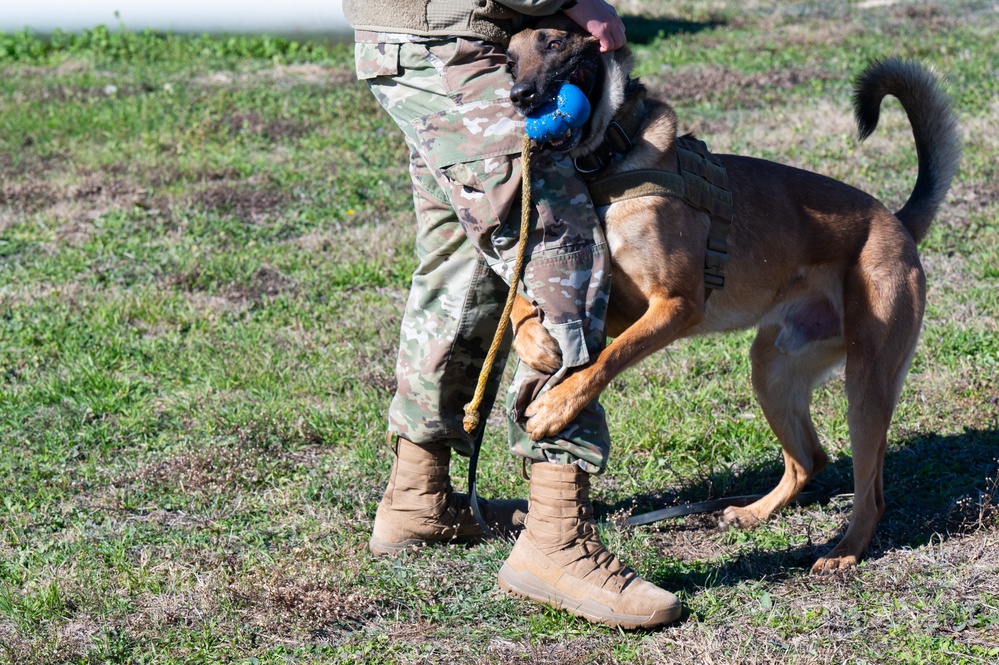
left=508, top=14, right=960, bottom=574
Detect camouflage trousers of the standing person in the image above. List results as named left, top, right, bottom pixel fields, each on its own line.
left=355, top=32, right=610, bottom=473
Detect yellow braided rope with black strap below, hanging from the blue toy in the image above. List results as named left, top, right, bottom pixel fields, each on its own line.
left=462, top=134, right=531, bottom=538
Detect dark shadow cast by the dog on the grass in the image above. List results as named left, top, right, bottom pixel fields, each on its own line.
left=597, top=428, right=999, bottom=591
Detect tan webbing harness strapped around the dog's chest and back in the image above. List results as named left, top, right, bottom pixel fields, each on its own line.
left=588, top=134, right=732, bottom=293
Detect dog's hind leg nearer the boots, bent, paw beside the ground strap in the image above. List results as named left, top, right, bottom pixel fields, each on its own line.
left=721, top=326, right=844, bottom=527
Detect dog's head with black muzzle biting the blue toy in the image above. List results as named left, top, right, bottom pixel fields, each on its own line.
left=507, top=14, right=606, bottom=151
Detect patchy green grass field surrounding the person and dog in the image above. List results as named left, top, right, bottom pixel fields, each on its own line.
left=0, top=0, right=999, bottom=665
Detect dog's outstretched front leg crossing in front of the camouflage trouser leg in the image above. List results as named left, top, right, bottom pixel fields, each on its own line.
left=525, top=296, right=704, bottom=441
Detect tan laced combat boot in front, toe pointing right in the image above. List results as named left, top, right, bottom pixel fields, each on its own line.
left=499, top=462, right=680, bottom=628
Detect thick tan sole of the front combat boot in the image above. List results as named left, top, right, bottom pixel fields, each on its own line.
left=499, top=564, right=683, bottom=630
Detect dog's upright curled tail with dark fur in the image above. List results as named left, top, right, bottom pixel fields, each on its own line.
left=853, top=58, right=961, bottom=242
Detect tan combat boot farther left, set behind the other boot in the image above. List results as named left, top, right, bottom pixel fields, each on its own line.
left=368, top=437, right=527, bottom=556
